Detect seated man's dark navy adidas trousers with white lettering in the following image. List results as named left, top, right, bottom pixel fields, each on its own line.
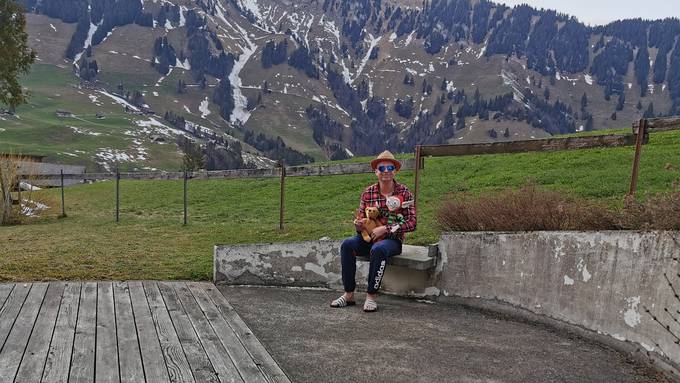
left=340, top=234, right=401, bottom=294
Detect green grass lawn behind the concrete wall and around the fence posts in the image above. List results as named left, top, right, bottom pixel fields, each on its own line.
left=0, top=131, right=680, bottom=281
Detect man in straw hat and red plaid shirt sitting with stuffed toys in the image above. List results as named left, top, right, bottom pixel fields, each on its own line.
left=331, top=150, right=416, bottom=312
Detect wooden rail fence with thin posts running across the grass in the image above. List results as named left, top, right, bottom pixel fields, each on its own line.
left=15, top=117, right=680, bottom=230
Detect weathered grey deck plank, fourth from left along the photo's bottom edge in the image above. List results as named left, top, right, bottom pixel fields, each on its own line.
left=69, top=282, right=97, bottom=383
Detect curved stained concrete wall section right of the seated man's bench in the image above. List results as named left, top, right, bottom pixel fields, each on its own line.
left=432, top=231, right=680, bottom=369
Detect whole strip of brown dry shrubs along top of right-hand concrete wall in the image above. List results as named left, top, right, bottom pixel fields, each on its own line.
left=435, top=183, right=680, bottom=231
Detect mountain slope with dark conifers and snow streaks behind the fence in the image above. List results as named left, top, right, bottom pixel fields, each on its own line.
left=0, top=0, right=680, bottom=168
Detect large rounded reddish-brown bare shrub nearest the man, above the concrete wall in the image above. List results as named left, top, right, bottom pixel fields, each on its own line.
left=435, top=185, right=620, bottom=231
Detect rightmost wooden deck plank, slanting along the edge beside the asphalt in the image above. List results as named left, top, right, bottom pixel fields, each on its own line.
left=197, top=282, right=290, bottom=383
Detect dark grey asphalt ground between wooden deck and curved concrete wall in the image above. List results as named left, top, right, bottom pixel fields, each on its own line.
left=219, top=286, right=665, bottom=383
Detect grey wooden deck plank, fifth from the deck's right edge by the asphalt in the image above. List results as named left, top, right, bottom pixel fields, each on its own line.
left=143, top=282, right=194, bottom=382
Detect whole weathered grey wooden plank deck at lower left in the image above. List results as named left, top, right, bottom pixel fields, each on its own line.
left=0, top=282, right=290, bottom=383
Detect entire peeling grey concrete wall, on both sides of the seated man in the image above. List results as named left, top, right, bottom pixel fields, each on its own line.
left=214, top=231, right=680, bottom=374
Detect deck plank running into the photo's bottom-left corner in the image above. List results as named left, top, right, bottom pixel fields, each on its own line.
left=0, top=283, right=48, bottom=382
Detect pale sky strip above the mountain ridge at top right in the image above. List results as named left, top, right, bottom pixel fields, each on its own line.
left=495, top=0, right=680, bottom=25
